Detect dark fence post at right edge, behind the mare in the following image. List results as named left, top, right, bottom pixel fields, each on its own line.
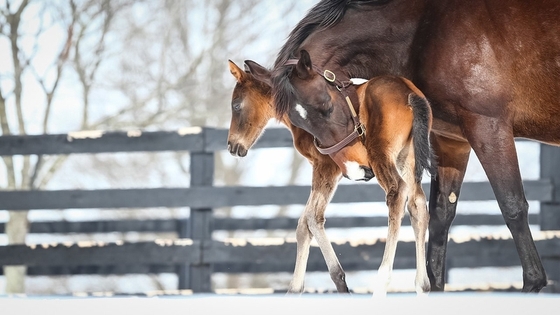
left=539, top=144, right=560, bottom=292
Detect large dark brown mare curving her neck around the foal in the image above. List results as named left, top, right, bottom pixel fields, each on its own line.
left=271, top=0, right=560, bottom=292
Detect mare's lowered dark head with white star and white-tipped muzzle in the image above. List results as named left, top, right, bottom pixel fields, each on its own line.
left=278, top=50, right=374, bottom=181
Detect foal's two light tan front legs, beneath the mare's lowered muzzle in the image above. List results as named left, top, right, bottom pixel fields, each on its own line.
left=288, top=162, right=348, bottom=293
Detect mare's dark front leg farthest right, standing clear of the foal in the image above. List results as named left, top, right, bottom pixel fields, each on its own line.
left=464, top=115, right=547, bottom=292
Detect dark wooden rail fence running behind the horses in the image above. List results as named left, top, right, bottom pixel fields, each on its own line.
left=0, top=128, right=560, bottom=292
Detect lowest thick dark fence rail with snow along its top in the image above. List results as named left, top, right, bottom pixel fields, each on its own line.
left=0, top=237, right=560, bottom=273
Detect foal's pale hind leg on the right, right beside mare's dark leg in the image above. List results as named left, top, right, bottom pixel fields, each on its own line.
left=407, top=178, right=430, bottom=293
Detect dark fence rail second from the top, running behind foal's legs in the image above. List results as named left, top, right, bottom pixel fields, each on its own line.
left=0, top=179, right=553, bottom=210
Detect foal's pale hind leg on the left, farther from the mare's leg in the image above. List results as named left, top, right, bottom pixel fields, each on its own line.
left=371, top=162, right=409, bottom=297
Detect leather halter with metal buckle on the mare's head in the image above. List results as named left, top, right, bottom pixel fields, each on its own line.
left=284, top=59, right=366, bottom=155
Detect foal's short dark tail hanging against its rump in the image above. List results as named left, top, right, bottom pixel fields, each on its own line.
left=408, top=93, right=437, bottom=182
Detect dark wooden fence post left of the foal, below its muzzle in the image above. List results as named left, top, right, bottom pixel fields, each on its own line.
left=179, top=128, right=214, bottom=293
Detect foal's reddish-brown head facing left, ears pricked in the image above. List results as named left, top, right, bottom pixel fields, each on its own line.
left=228, top=60, right=275, bottom=157
